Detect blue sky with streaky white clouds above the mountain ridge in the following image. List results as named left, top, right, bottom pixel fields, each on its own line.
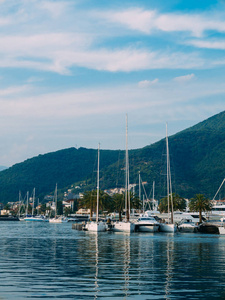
left=0, top=0, right=225, bottom=167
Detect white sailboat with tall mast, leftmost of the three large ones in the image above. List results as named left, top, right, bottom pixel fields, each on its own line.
left=84, top=144, right=106, bottom=232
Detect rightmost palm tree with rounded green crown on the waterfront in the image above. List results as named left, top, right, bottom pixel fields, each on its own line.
left=189, top=194, right=212, bottom=223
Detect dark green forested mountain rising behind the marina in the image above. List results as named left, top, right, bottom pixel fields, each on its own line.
left=0, top=112, right=225, bottom=202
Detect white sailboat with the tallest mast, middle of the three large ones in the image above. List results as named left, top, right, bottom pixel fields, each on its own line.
left=112, top=115, right=135, bottom=232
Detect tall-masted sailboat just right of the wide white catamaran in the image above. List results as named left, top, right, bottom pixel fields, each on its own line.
left=160, top=124, right=177, bottom=232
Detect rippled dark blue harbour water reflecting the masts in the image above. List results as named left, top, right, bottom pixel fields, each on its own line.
left=0, top=222, right=225, bottom=300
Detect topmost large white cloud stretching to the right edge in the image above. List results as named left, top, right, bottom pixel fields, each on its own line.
left=98, top=8, right=225, bottom=37
